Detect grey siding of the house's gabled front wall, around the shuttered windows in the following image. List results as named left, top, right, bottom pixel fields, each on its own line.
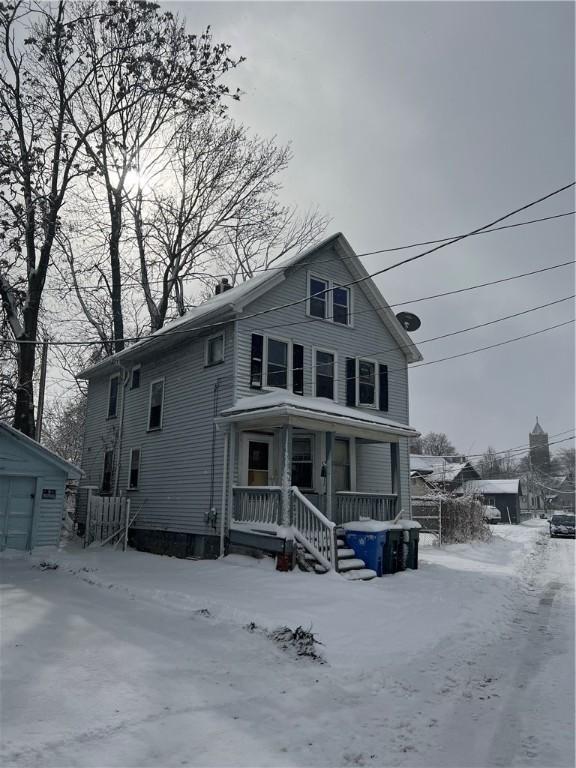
left=235, top=242, right=410, bottom=510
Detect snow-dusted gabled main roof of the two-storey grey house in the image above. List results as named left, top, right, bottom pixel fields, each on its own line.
left=77, top=232, right=422, bottom=379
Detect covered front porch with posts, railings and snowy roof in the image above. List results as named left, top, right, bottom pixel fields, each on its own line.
left=219, top=393, right=418, bottom=568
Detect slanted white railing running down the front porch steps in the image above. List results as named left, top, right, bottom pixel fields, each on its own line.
left=290, top=486, right=338, bottom=571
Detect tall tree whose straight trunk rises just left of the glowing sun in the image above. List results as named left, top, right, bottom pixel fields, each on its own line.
left=62, top=0, right=238, bottom=352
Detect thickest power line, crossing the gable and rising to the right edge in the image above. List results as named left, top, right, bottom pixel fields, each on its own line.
left=7, top=182, right=576, bottom=346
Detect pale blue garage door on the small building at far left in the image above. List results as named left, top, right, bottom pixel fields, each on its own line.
left=0, top=476, right=36, bottom=550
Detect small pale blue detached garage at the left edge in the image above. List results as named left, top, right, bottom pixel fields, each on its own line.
left=0, top=422, right=82, bottom=551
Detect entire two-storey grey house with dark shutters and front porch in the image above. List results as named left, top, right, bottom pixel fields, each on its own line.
left=78, top=234, right=422, bottom=568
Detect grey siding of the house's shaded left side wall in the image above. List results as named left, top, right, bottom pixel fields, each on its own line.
left=78, top=324, right=234, bottom=535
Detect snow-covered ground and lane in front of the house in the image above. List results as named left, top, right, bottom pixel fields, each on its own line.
left=0, top=521, right=574, bottom=768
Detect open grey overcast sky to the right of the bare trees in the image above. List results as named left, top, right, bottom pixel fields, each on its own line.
left=165, top=2, right=574, bottom=453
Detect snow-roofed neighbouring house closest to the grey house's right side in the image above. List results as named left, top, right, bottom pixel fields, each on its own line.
left=410, top=454, right=480, bottom=497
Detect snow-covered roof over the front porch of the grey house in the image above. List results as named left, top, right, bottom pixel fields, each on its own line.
left=217, top=392, right=420, bottom=442
